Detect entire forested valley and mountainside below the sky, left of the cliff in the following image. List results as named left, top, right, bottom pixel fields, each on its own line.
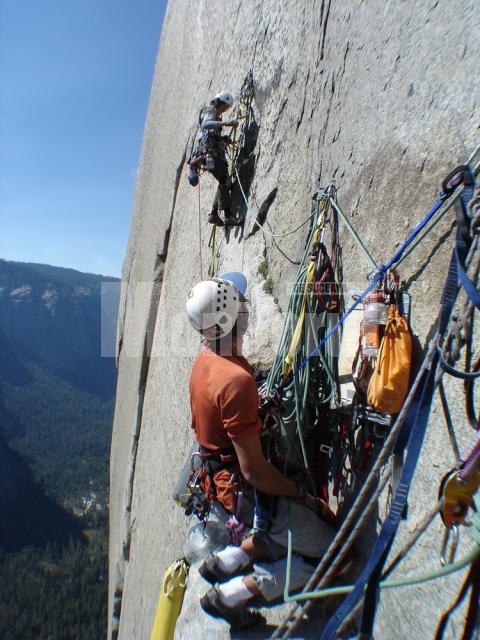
left=0, top=260, right=118, bottom=640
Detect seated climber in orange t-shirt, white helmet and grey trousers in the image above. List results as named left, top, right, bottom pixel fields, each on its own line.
left=187, top=272, right=335, bottom=628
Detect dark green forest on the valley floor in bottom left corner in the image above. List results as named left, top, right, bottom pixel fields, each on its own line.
left=0, top=527, right=107, bottom=640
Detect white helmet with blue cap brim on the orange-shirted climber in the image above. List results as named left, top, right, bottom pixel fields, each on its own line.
left=187, top=272, right=247, bottom=340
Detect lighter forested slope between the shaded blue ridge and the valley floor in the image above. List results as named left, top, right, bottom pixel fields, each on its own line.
left=0, top=364, right=114, bottom=506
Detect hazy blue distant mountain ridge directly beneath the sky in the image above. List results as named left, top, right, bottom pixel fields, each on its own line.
left=0, top=260, right=119, bottom=397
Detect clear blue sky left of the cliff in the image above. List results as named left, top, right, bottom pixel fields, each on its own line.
left=0, top=0, right=166, bottom=276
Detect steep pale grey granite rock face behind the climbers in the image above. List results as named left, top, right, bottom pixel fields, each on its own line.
left=109, top=0, right=480, bottom=640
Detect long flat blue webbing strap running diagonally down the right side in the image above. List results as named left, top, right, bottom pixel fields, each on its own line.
left=321, top=169, right=474, bottom=640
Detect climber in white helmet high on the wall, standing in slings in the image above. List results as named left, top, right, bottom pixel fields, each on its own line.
left=188, top=91, right=238, bottom=226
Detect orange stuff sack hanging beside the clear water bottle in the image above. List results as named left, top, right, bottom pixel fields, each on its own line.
left=367, top=304, right=412, bottom=413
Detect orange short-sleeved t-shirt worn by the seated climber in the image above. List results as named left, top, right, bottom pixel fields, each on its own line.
left=190, top=347, right=262, bottom=512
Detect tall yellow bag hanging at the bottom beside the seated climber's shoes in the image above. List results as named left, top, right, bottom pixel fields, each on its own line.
left=150, top=559, right=189, bottom=640
